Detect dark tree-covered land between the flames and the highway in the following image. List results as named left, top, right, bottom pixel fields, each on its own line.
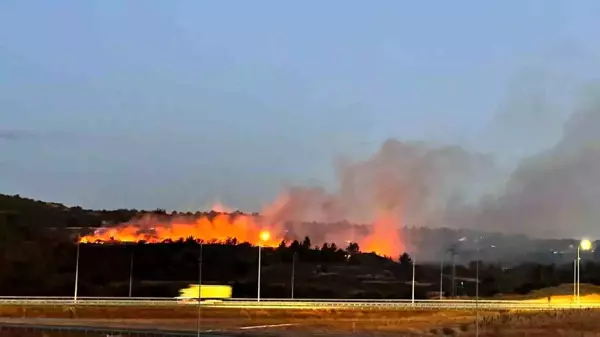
left=0, top=195, right=600, bottom=298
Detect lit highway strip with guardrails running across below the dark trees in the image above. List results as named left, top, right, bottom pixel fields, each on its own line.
left=0, top=297, right=600, bottom=310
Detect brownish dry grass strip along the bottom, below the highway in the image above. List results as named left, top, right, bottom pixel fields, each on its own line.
left=0, top=306, right=600, bottom=337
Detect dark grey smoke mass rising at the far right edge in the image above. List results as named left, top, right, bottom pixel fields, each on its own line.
left=471, top=88, right=600, bottom=237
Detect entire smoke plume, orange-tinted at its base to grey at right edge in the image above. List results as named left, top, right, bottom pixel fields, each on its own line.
left=264, top=80, right=600, bottom=252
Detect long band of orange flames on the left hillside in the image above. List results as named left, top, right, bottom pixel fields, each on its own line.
left=80, top=214, right=283, bottom=247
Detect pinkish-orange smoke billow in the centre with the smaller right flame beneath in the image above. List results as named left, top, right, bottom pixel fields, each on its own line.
left=263, top=139, right=493, bottom=257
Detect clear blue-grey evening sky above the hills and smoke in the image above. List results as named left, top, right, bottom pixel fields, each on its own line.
left=0, top=0, right=600, bottom=211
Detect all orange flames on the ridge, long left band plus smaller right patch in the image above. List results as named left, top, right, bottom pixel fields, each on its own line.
left=79, top=202, right=403, bottom=258
